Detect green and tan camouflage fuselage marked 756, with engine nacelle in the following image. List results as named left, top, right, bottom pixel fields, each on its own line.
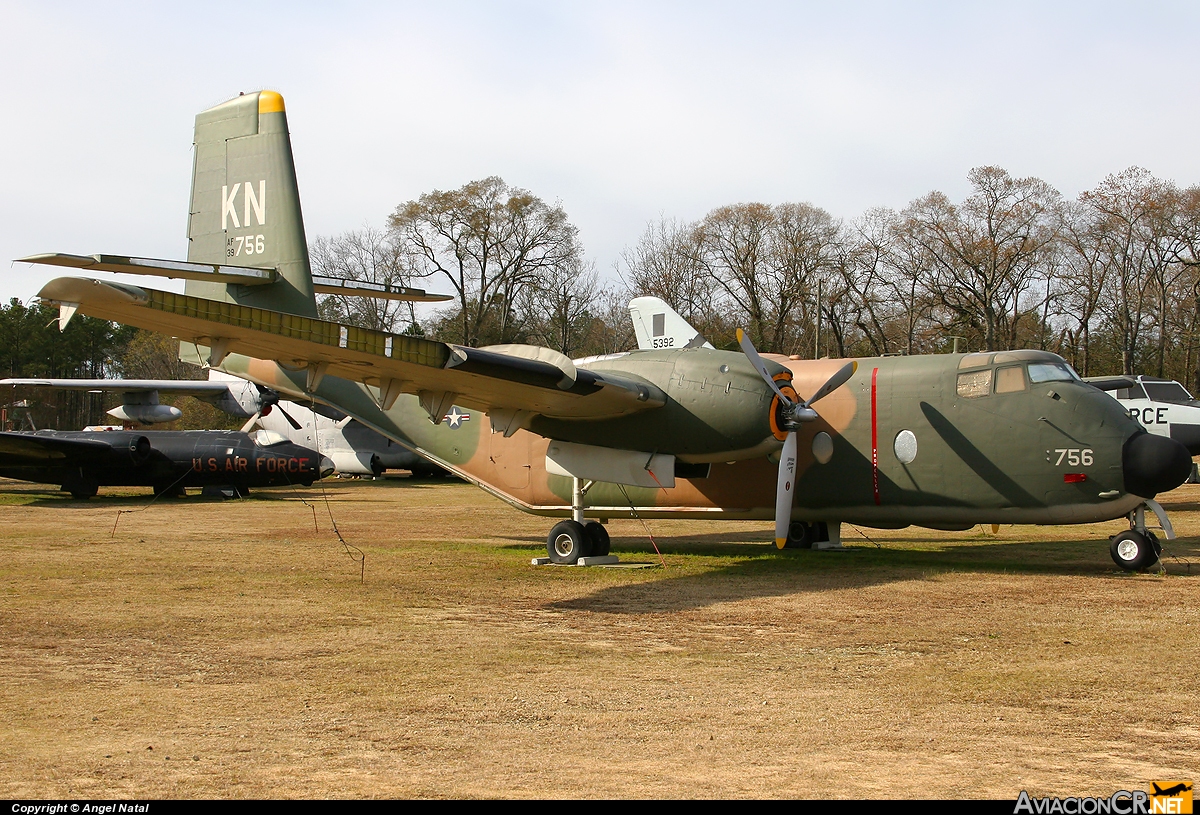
left=218, top=348, right=1171, bottom=527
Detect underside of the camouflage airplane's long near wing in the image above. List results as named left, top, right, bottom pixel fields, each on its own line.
left=38, top=277, right=666, bottom=421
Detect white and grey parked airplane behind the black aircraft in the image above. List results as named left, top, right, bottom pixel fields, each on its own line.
left=0, top=370, right=445, bottom=478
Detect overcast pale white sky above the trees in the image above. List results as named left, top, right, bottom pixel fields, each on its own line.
left=0, top=0, right=1200, bottom=301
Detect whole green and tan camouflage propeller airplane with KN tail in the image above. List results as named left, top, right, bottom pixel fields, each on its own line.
left=16, top=91, right=1192, bottom=569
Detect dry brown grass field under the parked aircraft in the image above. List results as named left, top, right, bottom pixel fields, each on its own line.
left=0, top=479, right=1200, bottom=798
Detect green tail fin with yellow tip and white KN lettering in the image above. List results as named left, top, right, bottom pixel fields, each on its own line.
left=184, top=90, right=317, bottom=317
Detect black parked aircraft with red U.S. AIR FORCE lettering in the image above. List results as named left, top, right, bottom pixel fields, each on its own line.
left=0, top=430, right=334, bottom=499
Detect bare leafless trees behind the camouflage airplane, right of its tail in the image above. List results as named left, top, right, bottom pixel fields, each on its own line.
left=312, top=167, right=1200, bottom=388
